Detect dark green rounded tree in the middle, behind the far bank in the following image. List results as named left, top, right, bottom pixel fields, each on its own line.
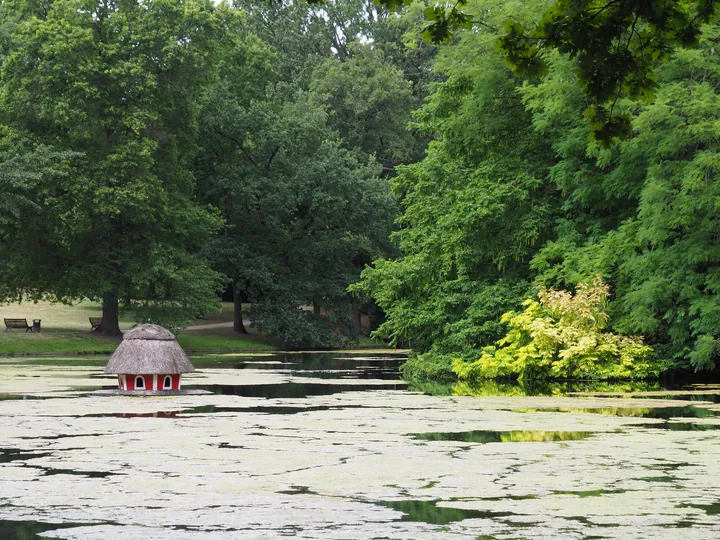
left=200, top=80, right=394, bottom=347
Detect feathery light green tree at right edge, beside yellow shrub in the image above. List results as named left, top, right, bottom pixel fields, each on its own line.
left=533, top=25, right=720, bottom=369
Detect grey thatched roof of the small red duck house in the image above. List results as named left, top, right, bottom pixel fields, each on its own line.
left=105, top=324, right=195, bottom=375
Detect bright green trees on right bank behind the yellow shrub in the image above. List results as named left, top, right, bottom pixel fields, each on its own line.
left=359, top=1, right=720, bottom=375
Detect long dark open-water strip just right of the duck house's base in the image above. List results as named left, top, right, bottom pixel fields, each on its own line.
left=192, top=382, right=407, bottom=399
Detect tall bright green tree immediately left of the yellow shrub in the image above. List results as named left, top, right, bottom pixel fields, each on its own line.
left=356, top=2, right=557, bottom=362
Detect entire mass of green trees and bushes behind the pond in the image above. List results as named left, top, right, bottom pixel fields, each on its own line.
left=0, top=0, right=720, bottom=377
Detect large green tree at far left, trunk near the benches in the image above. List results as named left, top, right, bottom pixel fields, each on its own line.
left=0, top=0, right=229, bottom=334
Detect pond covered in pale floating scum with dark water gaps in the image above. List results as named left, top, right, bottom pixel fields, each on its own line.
left=0, top=351, right=720, bottom=540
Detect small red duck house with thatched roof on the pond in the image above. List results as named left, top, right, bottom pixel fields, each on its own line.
left=105, top=324, right=195, bottom=393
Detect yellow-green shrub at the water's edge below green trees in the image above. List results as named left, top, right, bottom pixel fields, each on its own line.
left=453, top=278, right=664, bottom=380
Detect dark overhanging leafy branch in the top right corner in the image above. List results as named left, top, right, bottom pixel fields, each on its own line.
left=498, top=0, right=720, bottom=145
